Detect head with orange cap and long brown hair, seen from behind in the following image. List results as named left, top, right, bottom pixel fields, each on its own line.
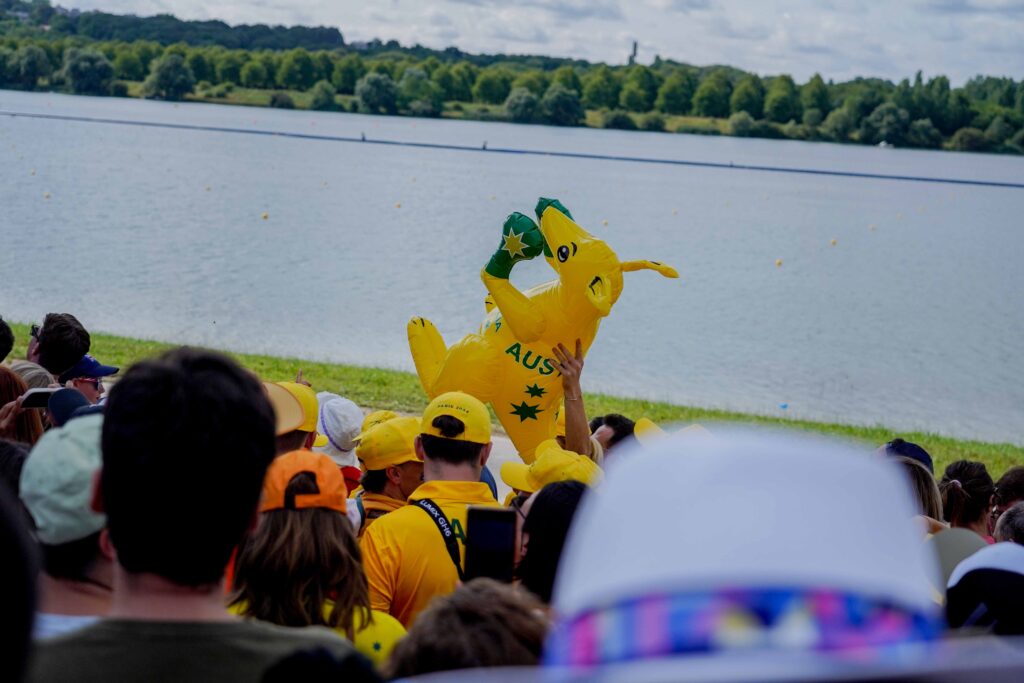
left=231, top=451, right=370, bottom=637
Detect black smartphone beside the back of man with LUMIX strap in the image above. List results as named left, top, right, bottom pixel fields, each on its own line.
left=465, top=506, right=516, bottom=583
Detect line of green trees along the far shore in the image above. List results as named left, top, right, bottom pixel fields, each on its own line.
left=0, top=7, right=1024, bottom=154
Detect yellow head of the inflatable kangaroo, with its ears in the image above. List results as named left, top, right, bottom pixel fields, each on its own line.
left=540, top=198, right=679, bottom=317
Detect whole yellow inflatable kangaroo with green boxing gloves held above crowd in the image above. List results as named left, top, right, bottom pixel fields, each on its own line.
left=408, top=198, right=679, bottom=463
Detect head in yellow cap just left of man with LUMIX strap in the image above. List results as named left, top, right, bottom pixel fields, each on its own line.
left=355, top=418, right=423, bottom=501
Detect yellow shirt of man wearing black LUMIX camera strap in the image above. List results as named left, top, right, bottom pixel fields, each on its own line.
left=359, top=481, right=498, bottom=629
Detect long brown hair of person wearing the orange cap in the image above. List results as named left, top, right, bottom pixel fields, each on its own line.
left=228, top=472, right=372, bottom=640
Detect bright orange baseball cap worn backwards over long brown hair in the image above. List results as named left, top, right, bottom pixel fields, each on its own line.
left=259, top=451, right=348, bottom=514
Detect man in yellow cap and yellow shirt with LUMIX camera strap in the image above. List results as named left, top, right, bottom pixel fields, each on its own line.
left=360, top=391, right=500, bottom=628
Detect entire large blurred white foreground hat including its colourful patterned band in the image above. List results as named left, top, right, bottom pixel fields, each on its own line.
left=545, top=431, right=942, bottom=671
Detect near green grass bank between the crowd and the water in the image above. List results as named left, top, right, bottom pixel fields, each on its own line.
left=12, top=325, right=1024, bottom=477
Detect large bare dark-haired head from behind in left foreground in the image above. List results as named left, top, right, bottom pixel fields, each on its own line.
left=100, top=348, right=274, bottom=588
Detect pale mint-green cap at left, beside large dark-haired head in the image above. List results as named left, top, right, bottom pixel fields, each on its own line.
left=20, top=415, right=106, bottom=546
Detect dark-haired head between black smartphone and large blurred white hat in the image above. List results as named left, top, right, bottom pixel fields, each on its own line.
left=516, top=481, right=587, bottom=603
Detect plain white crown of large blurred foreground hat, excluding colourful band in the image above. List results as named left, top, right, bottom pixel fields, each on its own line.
left=553, top=430, right=938, bottom=618
